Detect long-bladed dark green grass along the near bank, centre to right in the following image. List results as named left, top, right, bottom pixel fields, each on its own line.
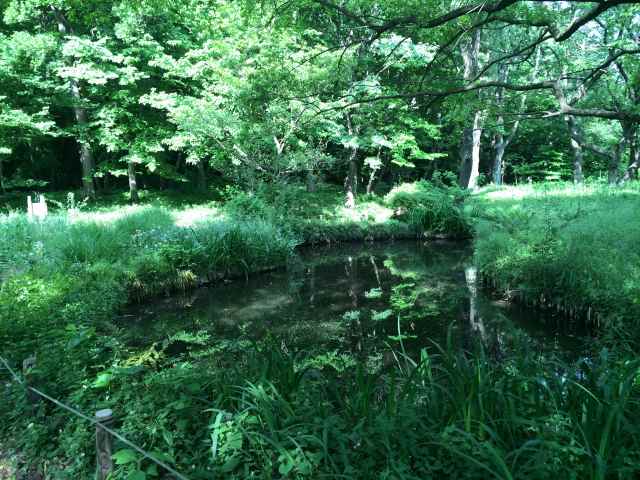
left=190, top=334, right=640, bottom=479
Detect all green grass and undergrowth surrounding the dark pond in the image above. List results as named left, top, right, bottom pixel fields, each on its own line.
left=0, top=183, right=640, bottom=479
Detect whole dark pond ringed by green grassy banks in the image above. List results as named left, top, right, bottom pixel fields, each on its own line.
left=122, top=241, right=585, bottom=357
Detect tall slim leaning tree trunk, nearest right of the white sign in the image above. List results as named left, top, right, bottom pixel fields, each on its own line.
left=52, top=7, right=96, bottom=198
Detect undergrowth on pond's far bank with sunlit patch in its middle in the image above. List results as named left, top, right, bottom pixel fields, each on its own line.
left=226, top=181, right=470, bottom=244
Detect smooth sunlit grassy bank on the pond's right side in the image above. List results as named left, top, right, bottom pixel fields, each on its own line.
left=467, top=184, right=640, bottom=344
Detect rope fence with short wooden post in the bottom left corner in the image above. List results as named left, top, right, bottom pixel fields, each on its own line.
left=0, top=356, right=189, bottom=480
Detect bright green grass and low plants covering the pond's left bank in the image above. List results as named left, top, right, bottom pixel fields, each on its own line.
left=0, top=208, right=295, bottom=393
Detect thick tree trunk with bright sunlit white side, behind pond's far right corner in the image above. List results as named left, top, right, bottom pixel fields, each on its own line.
left=460, top=29, right=482, bottom=189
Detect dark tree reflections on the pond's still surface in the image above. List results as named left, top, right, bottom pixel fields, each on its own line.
left=121, top=244, right=576, bottom=365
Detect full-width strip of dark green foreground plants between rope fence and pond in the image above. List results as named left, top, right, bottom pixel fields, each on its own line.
left=0, top=335, right=640, bottom=480
